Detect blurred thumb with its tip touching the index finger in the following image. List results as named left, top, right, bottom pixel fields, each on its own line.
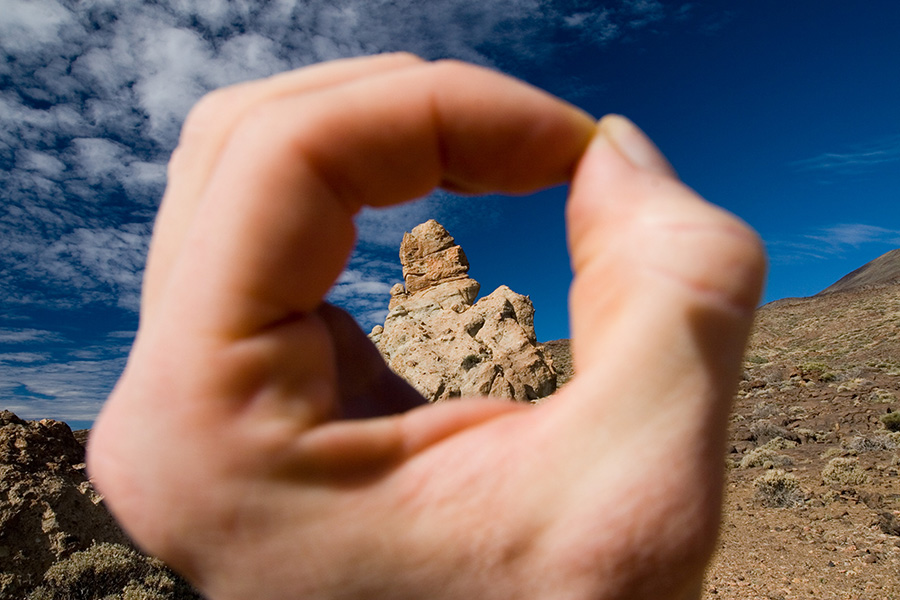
left=567, top=116, right=765, bottom=434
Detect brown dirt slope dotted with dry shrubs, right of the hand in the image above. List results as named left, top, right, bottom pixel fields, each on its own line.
left=703, top=286, right=900, bottom=600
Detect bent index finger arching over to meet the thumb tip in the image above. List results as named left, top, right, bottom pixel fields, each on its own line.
left=159, top=62, right=595, bottom=337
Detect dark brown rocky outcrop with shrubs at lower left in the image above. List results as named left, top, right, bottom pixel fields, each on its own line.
left=0, top=411, right=199, bottom=600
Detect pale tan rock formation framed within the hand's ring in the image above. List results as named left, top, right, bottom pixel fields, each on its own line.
left=369, top=220, right=556, bottom=402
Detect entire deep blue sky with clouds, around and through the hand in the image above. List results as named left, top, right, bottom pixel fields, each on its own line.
left=0, top=0, right=900, bottom=426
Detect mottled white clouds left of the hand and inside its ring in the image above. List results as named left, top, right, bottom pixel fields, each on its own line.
left=0, top=0, right=704, bottom=418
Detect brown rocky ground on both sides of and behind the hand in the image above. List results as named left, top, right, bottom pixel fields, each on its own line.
left=7, top=274, right=900, bottom=600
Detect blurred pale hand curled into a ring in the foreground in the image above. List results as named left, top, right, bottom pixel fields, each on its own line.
left=89, top=54, right=765, bottom=600
